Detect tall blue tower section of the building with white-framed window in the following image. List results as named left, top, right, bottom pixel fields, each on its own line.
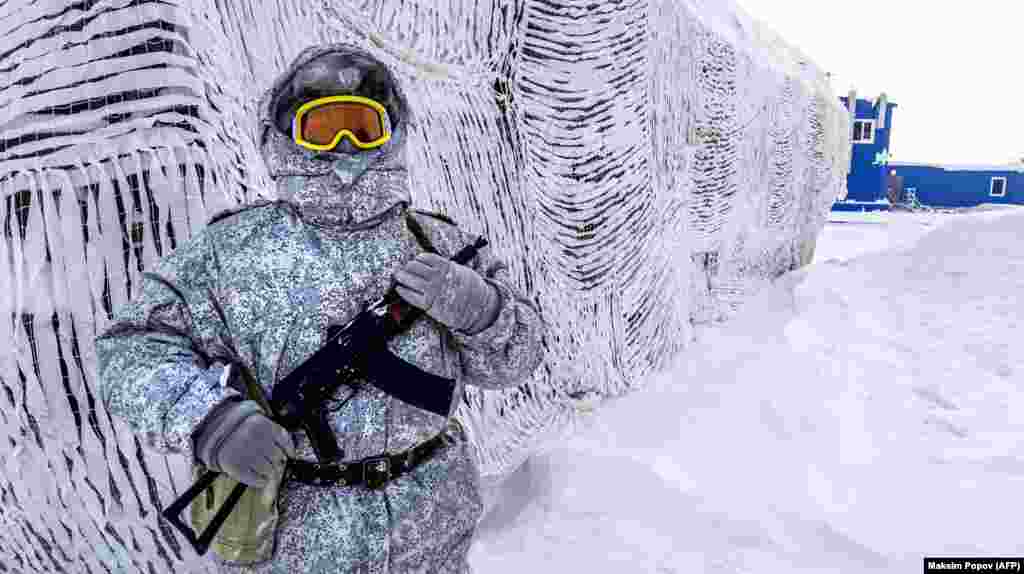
left=833, top=93, right=897, bottom=212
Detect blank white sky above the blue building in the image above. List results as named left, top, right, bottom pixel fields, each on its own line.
left=734, top=0, right=1024, bottom=164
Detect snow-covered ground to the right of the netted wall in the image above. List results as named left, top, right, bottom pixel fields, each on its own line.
left=471, top=209, right=1024, bottom=574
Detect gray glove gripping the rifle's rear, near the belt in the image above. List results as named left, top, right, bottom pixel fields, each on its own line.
left=194, top=401, right=295, bottom=488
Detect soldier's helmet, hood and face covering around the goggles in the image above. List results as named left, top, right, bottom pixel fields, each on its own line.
left=258, top=44, right=411, bottom=230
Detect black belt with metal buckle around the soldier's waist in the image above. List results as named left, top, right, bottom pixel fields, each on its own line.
left=288, top=433, right=453, bottom=490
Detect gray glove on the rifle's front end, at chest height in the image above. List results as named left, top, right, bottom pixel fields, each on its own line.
left=394, top=253, right=502, bottom=335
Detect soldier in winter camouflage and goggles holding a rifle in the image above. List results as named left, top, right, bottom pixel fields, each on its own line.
left=97, top=45, right=542, bottom=574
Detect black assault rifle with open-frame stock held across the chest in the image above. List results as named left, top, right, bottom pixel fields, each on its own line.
left=161, top=237, right=487, bottom=556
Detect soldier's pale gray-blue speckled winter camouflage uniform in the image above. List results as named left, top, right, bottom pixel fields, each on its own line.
left=97, top=46, right=541, bottom=574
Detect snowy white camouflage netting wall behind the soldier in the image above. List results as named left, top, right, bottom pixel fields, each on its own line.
left=0, top=0, right=849, bottom=574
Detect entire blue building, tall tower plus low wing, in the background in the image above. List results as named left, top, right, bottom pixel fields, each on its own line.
left=833, top=92, right=1024, bottom=212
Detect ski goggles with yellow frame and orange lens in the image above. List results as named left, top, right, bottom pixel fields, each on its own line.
left=292, top=95, right=391, bottom=151
